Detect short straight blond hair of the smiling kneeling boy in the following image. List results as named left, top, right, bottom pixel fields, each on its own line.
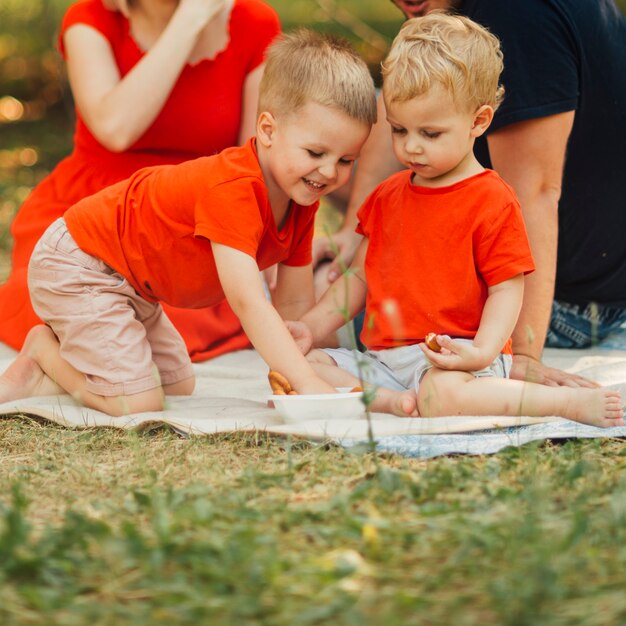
left=259, top=29, right=376, bottom=124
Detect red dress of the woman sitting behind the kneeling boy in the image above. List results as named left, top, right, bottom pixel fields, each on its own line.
left=0, top=0, right=280, bottom=361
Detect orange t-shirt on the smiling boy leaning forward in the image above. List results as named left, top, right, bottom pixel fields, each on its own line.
left=65, top=139, right=317, bottom=308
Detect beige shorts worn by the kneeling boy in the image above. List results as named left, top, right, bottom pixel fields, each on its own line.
left=28, top=218, right=193, bottom=396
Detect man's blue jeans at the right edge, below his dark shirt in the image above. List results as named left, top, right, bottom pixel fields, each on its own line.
left=546, top=300, right=626, bottom=348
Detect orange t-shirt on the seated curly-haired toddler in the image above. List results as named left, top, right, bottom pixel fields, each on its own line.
left=357, top=170, right=535, bottom=352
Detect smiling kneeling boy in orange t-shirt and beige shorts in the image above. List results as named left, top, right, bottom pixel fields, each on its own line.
left=0, top=31, right=376, bottom=415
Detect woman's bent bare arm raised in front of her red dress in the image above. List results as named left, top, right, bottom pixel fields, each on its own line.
left=64, top=0, right=226, bottom=152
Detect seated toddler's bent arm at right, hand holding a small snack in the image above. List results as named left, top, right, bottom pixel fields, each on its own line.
left=420, top=274, right=524, bottom=371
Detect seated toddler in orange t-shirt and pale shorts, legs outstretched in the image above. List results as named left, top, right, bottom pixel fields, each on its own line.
left=290, top=12, right=624, bottom=426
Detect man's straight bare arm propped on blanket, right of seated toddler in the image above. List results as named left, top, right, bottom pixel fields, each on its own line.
left=487, top=111, right=594, bottom=386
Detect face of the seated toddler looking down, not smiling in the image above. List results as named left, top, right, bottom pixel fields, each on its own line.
left=386, top=86, right=480, bottom=187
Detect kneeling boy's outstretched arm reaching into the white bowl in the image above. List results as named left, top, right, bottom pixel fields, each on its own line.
left=211, top=242, right=336, bottom=393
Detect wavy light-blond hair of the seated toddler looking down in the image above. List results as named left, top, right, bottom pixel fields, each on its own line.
left=382, top=11, right=504, bottom=112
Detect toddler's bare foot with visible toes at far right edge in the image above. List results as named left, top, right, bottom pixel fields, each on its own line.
left=563, top=388, right=624, bottom=428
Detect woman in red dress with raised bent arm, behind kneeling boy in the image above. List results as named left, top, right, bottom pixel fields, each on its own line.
left=0, top=0, right=280, bottom=361
